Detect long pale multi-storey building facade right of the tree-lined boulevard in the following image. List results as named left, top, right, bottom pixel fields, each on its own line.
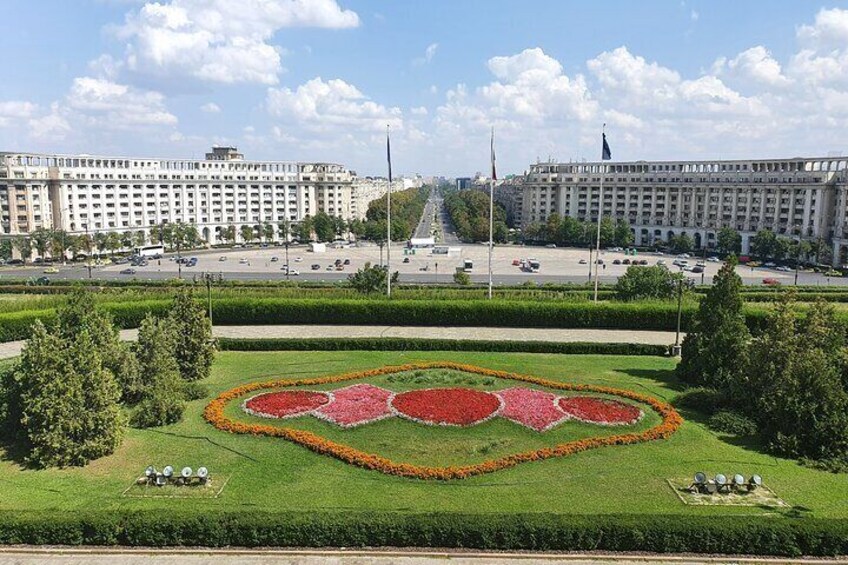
left=521, top=157, right=848, bottom=264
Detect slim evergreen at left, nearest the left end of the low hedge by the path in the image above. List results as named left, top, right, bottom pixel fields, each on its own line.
left=168, top=288, right=215, bottom=382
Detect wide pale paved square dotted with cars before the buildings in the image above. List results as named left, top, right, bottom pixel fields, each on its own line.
left=0, top=243, right=848, bottom=286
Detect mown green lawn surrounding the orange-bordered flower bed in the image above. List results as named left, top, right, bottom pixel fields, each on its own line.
left=0, top=351, right=848, bottom=518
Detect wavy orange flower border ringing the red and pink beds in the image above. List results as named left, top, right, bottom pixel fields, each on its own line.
left=203, top=361, right=683, bottom=480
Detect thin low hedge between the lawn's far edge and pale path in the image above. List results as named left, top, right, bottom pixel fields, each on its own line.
left=218, top=337, right=668, bottom=355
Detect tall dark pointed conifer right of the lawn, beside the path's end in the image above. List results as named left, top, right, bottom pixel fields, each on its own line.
left=677, top=255, right=751, bottom=394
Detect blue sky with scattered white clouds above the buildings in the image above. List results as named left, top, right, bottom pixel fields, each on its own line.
left=0, top=0, right=848, bottom=176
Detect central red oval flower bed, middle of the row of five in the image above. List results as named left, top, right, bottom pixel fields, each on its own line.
left=392, top=388, right=501, bottom=426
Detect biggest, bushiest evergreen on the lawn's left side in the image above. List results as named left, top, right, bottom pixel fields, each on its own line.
left=15, top=321, right=126, bottom=467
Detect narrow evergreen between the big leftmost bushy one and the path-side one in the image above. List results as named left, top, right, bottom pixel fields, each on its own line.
left=132, top=314, right=185, bottom=428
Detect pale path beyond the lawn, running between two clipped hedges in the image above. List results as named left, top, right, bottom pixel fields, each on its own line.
left=0, top=326, right=674, bottom=359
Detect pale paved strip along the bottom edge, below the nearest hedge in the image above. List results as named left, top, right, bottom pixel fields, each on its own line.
left=0, top=547, right=848, bottom=565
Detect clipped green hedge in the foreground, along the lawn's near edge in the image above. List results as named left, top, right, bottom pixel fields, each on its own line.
left=0, top=508, right=848, bottom=557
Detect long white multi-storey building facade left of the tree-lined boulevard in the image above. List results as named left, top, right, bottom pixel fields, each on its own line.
left=0, top=147, right=352, bottom=244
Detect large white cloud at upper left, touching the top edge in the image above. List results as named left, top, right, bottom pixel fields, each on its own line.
left=116, top=0, right=359, bottom=84
